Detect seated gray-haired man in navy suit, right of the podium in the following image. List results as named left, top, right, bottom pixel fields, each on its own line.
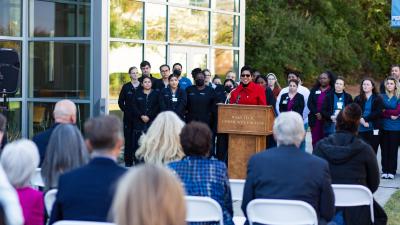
left=242, top=112, right=335, bottom=224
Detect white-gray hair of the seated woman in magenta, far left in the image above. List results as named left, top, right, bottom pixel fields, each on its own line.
left=0, top=139, right=39, bottom=188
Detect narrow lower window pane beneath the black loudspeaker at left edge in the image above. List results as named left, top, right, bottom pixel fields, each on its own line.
left=2, top=102, right=22, bottom=142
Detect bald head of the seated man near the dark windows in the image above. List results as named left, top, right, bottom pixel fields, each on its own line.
left=53, top=99, right=76, bottom=123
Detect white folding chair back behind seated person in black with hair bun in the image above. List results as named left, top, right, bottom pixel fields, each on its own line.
left=332, top=184, right=375, bottom=222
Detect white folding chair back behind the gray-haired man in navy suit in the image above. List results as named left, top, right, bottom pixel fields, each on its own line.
left=246, top=199, right=318, bottom=225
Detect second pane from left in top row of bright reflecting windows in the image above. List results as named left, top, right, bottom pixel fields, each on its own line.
left=146, top=3, right=167, bottom=41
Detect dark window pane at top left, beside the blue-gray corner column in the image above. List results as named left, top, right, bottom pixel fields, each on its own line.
left=30, top=0, right=90, bottom=37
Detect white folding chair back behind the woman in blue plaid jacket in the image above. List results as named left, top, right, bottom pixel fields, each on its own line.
left=185, top=196, right=224, bottom=225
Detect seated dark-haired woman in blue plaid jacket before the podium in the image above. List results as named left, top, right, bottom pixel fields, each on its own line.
left=168, top=122, right=233, bottom=225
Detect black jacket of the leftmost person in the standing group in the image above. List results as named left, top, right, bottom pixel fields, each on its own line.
left=118, top=82, right=136, bottom=123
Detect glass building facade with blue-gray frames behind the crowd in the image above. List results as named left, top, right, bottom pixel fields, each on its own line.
left=0, top=0, right=245, bottom=140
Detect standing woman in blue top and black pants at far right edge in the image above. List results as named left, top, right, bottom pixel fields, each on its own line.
left=379, top=77, right=400, bottom=179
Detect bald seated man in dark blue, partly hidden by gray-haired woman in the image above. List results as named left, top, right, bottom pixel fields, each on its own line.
left=32, top=99, right=76, bottom=166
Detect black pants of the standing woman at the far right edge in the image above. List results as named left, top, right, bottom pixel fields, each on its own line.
left=379, top=130, right=400, bottom=174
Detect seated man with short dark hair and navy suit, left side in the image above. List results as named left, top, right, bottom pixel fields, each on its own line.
left=50, top=116, right=126, bottom=224
